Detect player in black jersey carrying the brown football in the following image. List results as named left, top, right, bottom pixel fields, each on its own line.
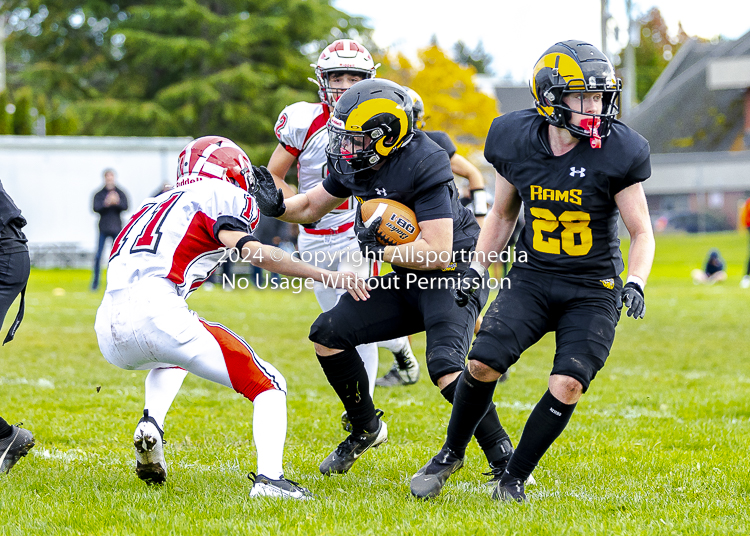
left=255, top=78, right=512, bottom=480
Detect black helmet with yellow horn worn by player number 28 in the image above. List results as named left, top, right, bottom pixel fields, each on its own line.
left=530, top=40, right=622, bottom=142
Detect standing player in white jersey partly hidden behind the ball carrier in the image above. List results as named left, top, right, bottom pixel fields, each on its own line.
left=268, top=39, right=419, bottom=402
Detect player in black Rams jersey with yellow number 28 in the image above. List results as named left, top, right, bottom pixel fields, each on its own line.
left=411, top=41, right=654, bottom=502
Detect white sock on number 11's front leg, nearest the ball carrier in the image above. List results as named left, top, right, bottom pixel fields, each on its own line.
left=253, top=389, right=286, bottom=480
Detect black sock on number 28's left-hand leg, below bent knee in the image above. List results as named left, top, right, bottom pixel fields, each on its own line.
left=445, top=369, right=499, bottom=457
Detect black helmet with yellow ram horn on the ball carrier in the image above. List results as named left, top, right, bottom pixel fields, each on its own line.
left=326, top=78, right=414, bottom=174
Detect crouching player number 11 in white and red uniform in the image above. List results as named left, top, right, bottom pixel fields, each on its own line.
left=95, top=136, right=368, bottom=499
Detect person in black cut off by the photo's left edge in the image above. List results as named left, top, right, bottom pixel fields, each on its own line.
left=0, top=178, right=34, bottom=472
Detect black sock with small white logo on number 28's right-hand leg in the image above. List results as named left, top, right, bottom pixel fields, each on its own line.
left=506, top=390, right=576, bottom=480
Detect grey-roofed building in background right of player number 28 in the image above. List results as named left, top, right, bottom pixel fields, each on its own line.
left=623, top=28, right=750, bottom=232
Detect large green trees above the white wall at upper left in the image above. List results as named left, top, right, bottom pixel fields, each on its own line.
left=4, top=0, right=371, bottom=162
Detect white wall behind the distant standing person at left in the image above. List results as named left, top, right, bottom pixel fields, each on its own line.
left=0, top=136, right=191, bottom=266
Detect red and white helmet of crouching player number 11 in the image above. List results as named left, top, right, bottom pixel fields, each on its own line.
left=176, top=136, right=255, bottom=193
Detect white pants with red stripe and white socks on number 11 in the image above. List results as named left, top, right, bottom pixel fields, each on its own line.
left=95, top=278, right=286, bottom=478
